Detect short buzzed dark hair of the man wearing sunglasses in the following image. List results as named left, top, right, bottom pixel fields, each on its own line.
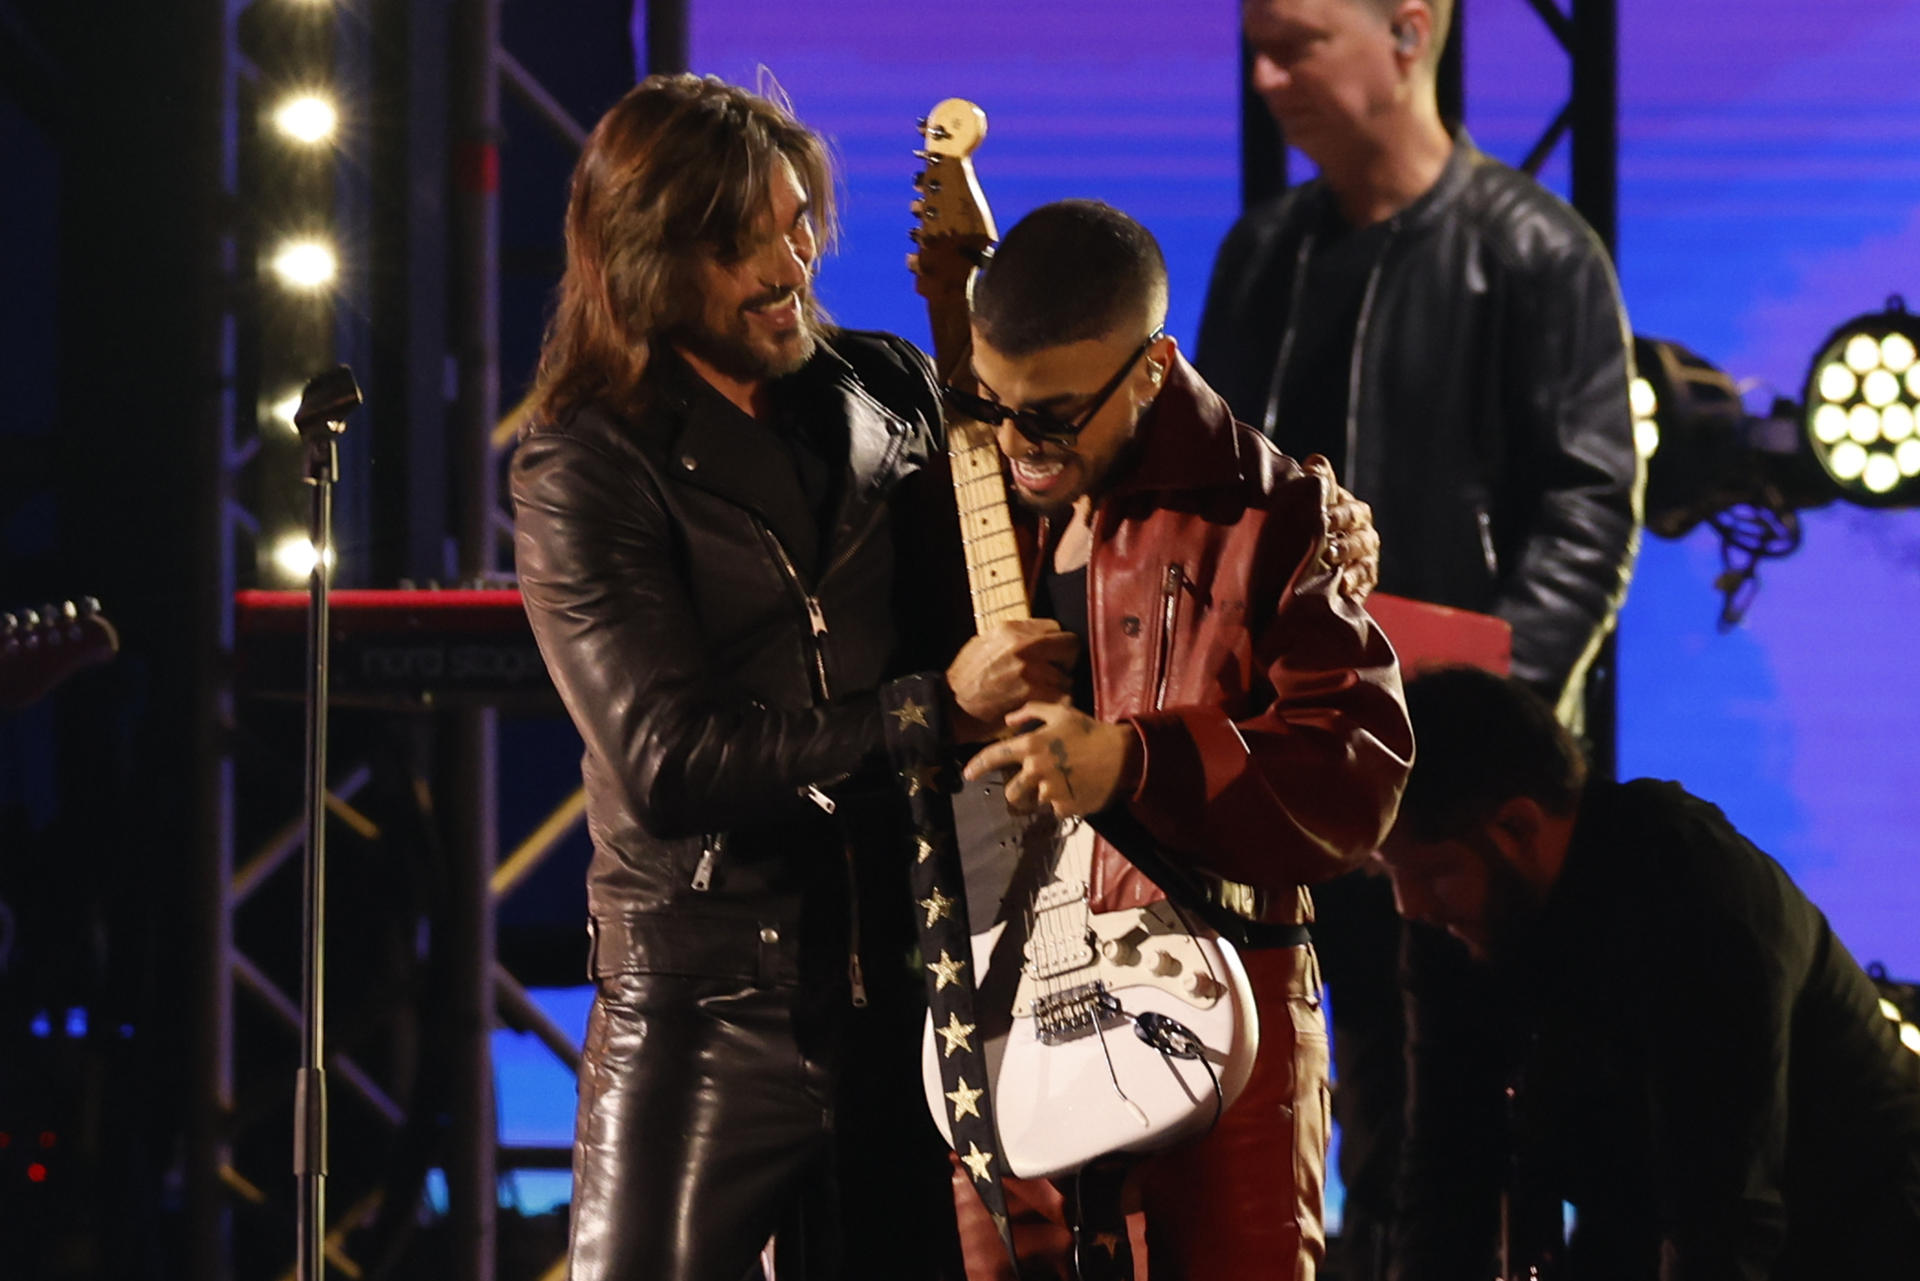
left=973, top=200, right=1167, bottom=357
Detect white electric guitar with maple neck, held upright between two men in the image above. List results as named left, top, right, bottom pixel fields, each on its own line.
left=910, top=98, right=1260, bottom=1177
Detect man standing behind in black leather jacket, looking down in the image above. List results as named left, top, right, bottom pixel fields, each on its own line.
left=1196, top=0, right=1642, bottom=1277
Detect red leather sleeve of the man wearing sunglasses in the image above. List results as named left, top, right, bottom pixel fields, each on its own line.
left=1127, top=471, right=1413, bottom=889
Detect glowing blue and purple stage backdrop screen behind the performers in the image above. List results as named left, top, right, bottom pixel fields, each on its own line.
left=501, top=0, right=1920, bottom=1221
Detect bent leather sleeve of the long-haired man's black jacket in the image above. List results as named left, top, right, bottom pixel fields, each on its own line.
left=513, top=432, right=881, bottom=837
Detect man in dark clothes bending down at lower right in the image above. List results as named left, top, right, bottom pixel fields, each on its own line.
left=1380, top=668, right=1920, bottom=1281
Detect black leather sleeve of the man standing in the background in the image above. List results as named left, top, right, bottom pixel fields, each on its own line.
left=1494, top=234, right=1645, bottom=711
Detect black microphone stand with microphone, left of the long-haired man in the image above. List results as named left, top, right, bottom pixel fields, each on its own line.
left=294, top=365, right=361, bottom=1281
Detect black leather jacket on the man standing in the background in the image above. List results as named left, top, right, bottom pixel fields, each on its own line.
left=1196, top=133, right=1644, bottom=699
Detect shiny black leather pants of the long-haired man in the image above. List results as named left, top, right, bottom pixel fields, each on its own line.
left=568, top=974, right=958, bottom=1281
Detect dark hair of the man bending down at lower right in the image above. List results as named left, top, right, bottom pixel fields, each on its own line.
left=1400, top=666, right=1586, bottom=841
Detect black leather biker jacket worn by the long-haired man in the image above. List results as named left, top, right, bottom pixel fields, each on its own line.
left=513, top=332, right=967, bottom=985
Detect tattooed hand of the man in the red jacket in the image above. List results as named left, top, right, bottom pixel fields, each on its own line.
left=966, top=703, right=1142, bottom=818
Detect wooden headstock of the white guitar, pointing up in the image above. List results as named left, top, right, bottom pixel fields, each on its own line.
left=906, top=98, right=1000, bottom=339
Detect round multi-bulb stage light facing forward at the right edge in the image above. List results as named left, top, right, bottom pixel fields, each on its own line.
left=1803, top=298, right=1920, bottom=507
